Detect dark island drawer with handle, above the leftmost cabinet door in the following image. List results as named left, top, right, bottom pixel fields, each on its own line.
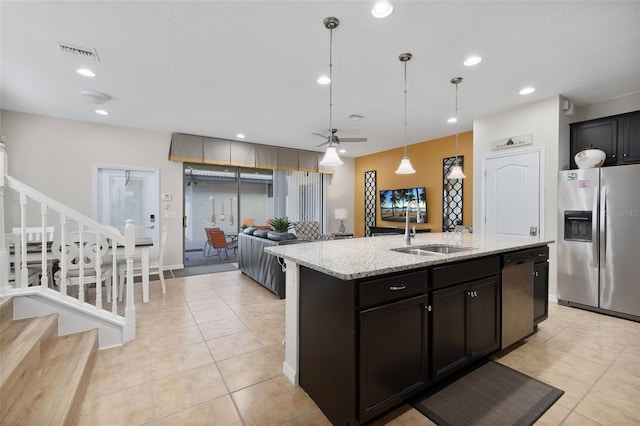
left=359, top=271, right=429, bottom=308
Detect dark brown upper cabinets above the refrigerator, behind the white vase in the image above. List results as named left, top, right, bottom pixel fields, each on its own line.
left=569, top=111, right=640, bottom=169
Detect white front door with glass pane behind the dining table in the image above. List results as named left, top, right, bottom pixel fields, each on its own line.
left=93, top=166, right=160, bottom=244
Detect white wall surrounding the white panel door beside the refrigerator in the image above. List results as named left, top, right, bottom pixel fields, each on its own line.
left=473, top=96, right=569, bottom=295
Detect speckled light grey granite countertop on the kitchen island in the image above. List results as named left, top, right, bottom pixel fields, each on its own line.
left=265, top=233, right=553, bottom=280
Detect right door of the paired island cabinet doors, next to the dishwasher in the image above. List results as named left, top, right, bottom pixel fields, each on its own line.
left=468, top=275, right=500, bottom=359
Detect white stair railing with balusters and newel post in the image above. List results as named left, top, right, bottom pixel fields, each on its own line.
left=0, top=143, right=136, bottom=341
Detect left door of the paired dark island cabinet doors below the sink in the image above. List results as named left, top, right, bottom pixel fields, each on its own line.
left=431, top=283, right=469, bottom=380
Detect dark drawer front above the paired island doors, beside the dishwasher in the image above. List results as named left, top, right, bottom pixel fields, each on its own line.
left=432, top=256, right=500, bottom=290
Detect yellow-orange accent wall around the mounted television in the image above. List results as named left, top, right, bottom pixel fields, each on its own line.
left=353, top=131, right=473, bottom=237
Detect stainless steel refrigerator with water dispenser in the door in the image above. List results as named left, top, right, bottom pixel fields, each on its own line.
left=558, top=164, right=640, bottom=321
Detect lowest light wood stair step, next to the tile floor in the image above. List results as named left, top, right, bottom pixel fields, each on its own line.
left=2, top=329, right=98, bottom=425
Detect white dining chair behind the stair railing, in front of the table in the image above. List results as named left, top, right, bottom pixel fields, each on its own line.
left=51, top=232, right=114, bottom=303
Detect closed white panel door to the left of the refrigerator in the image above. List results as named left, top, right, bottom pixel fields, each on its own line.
left=482, top=149, right=544, bottom=240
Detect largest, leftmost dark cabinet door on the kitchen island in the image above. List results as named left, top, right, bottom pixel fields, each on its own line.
left=359, top=295, right=429, bottom=422
